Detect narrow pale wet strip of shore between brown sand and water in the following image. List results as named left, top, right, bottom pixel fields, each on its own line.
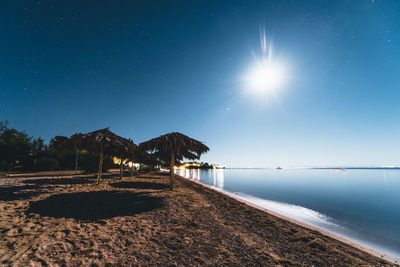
left=175, top=174, right=400, bottom=265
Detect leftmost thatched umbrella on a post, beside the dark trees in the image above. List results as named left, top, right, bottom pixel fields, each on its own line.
left=81, top=128, right=129, bottom=184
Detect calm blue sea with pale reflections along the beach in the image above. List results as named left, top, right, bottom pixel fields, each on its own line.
left=177, top=169, right=400, bottom=258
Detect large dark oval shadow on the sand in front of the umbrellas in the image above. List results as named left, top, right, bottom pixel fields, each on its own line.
left=26, top=191, right=163, bottom=221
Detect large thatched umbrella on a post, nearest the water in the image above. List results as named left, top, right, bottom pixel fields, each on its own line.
left=140, top=132, right=209, bottom=188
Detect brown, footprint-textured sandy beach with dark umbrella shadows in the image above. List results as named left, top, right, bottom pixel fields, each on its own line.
left=0, top=173, right=395, bottom=266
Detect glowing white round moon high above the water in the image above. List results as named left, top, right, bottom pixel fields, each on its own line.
left=246, top=59, right=286, bottom=93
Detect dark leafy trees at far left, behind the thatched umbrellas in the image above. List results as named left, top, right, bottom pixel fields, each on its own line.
left=0, top=121, right=114, bottom=171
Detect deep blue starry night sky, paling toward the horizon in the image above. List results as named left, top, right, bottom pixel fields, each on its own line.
left=0, top=0, right=400, bottom=167
